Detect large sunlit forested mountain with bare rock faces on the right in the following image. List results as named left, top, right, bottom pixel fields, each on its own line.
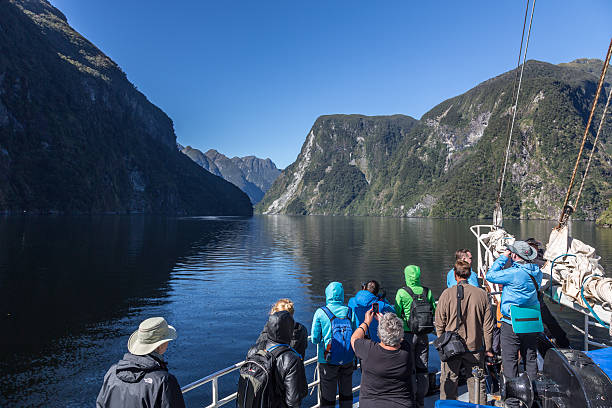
left=257, top=59, right=612, bottom=219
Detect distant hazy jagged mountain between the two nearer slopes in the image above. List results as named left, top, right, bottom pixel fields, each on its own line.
left=179, top=146, right=280, bottom=204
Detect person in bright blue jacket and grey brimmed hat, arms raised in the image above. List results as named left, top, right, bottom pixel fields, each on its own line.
left=486, top=241, right=542, bottom=379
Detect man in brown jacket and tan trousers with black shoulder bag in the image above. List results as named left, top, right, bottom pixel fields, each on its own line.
left=434, top=261, right=495, bottom=404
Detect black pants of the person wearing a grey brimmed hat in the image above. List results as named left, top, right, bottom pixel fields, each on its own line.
left=501, top=322, right=538, bottom=380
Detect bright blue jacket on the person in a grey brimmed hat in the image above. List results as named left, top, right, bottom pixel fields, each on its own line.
left=487, top=255, right=542, bottom=324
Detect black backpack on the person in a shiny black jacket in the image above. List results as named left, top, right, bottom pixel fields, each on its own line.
left=236, top=344, right=297, bottom=408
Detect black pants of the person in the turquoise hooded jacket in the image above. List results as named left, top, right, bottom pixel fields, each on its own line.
left=319, top=362, right=353, bottom=408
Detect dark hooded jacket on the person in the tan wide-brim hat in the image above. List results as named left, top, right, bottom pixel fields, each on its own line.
left=96, top=353, right=185, bottom=408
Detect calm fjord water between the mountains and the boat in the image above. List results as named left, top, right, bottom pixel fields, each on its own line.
left=0, top=216, right=612, bottom=407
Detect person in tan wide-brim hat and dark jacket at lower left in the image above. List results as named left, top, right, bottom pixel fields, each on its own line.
left=96, top=317, right=185, bottom=408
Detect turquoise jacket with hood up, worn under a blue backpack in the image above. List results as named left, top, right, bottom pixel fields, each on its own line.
left=310, top=282, right=357, bottom=363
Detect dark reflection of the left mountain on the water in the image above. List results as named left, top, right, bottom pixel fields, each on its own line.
left=0, top=216, right=246, bottom=406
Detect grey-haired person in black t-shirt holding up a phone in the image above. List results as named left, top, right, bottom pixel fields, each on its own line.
left=351, top=308, right=415, bottom=408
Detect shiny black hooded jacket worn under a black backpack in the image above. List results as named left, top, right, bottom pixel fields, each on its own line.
left=248, top=311, right=308, bottom=408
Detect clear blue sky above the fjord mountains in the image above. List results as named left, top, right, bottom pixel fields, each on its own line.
left=51, top=0, right=612, bottom=168
